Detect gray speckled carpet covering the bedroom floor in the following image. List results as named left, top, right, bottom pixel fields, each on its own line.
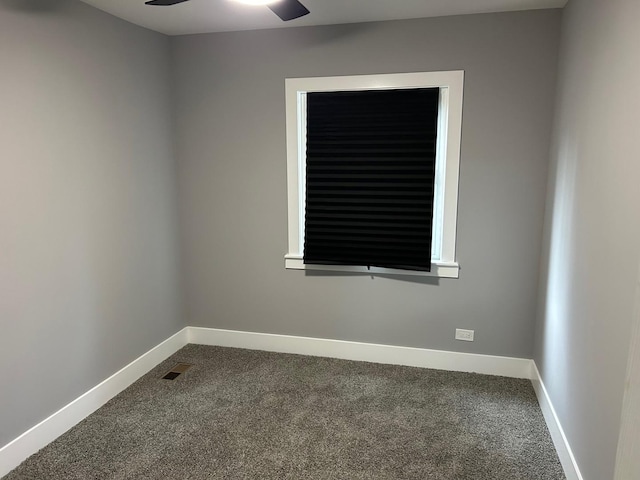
left=5, top=345, right=565, bottom=480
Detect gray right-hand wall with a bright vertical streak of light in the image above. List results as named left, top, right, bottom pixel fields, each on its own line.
left=534, top=0, right=640, bottom=480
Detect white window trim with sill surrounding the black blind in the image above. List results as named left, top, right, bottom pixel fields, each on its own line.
left=285, top=70, right=464, bottom=278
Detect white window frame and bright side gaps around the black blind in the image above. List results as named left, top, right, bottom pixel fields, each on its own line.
left=285, top=71, right=464, bottom=278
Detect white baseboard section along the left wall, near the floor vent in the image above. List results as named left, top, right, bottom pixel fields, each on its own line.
left=0, top=328, right=187, bottom=477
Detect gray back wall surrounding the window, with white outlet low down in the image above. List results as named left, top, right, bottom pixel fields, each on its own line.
left=171, top=10, right=560, bottom=357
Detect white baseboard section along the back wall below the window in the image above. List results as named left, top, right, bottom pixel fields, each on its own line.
left=188, top=327, right=531, bottom=379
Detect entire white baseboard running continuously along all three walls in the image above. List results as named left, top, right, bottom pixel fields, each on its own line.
left=0, top=327, right=582, bottom=480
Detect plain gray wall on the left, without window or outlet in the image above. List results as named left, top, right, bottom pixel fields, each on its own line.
left=0, top=0, right=183, bottom=446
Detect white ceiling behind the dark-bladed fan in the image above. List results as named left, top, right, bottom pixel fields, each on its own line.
left=82, top=0, right=567, bottom=35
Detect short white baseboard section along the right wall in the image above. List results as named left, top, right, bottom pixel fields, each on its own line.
left=531, top=362, right=583, bottom=480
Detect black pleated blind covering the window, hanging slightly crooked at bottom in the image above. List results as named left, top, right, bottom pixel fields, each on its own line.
left=304, top=88, right=440, bottom=271
